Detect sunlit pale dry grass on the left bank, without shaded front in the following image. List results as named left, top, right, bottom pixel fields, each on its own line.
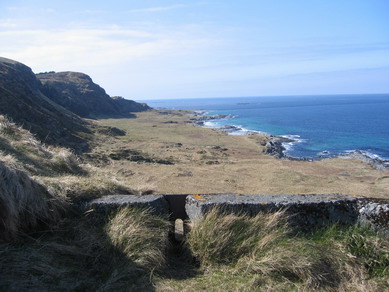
left=0, top=115, right=139, bottom=205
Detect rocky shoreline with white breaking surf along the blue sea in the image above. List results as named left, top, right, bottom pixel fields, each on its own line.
left=189, top=110, right=389, bottom=170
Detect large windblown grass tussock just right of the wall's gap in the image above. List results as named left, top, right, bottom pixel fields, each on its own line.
left=187, top=208, right=287, bottom=265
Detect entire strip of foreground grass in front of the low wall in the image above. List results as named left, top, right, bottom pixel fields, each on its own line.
left=0, top=208, right=389, bottom=292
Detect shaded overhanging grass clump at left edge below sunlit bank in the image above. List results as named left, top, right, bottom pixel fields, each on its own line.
left=0, top=161, right=66, bottom=239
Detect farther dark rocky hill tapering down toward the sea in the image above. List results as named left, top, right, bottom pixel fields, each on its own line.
left=36, top=72, right=150, bottom=118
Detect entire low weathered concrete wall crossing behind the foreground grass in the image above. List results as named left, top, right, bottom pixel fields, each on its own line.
left=83, top=194, right=389, bottom=236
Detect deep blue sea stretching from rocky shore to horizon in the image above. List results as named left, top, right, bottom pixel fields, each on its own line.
left=146, top=94, right=389, bottom=159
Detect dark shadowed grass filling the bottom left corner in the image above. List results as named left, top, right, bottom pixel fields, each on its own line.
left=0, top=209, right=155, bottom=291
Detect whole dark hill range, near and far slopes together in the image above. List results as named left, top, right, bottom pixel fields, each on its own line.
left=0, top=57, right=150, bottom=152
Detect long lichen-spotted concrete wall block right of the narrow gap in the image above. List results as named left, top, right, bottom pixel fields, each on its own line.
left=185, top=194, right=358, bottom=230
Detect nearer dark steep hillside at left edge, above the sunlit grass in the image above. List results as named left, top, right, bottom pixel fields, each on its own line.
left=0, top=57, right=91, bottom=148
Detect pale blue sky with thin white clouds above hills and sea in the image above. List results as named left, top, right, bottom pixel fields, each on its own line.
left=0, top=0, right=389, bottom=100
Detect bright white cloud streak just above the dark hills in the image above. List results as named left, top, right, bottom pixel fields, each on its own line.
left=0, top=28, right=216, bottom=73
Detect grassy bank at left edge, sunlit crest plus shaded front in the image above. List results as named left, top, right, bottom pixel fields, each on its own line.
left=0, top=116, right=137, bottom=243
